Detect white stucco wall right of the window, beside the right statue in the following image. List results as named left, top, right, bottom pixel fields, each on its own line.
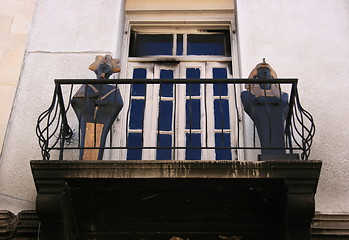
left=236, top=0, right=349, bottom=213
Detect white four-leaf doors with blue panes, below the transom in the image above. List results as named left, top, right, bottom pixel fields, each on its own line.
left=121, top=61, right=236, bottom=160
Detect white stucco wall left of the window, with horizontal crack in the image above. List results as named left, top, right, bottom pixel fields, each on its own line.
left=0, top=0, right=124, bottom=213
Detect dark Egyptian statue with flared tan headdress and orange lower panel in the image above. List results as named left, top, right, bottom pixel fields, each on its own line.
left=71, top=55, right=123, bottom=160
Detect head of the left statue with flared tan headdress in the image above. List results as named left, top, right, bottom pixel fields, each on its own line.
left=89, top=54, right=121, bottom=79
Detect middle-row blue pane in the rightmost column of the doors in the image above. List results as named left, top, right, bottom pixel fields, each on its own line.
left=214, top=99, right=230, bottom=129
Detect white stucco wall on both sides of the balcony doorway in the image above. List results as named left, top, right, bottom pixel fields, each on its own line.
left=0, top=0, right=349, bottom=216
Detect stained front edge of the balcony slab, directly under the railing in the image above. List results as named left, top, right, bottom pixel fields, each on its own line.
left=31, top=160, right=321, bottom=179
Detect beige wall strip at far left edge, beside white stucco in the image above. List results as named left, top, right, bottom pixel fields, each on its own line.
left=0, top=0, right=36, bottom=154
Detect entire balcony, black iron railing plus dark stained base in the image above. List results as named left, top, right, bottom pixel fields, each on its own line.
left=31, top=79, right=321, bottom=240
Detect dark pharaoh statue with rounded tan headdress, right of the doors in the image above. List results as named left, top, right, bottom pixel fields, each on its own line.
left=241, top=59, right=288, bottom=158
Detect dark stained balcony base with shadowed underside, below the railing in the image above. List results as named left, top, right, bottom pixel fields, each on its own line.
left=31, top=160, right=321, bottom=240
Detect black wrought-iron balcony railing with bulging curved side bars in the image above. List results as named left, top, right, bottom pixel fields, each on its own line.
left=36, top=79, right=315, bottom=160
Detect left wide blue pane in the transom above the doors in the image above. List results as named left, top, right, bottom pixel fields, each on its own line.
left=134, top=34, right=173, bottom=57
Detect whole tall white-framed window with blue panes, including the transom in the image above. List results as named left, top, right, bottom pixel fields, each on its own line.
left=114, top=16, right=238, bottom=160
